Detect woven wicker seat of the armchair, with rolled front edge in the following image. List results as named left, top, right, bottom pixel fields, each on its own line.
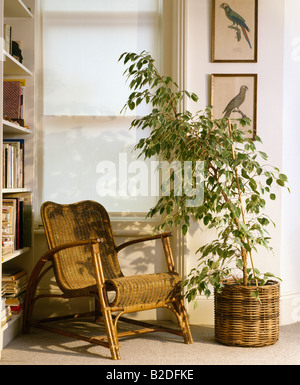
left=106, top=272, right=182, bottom=307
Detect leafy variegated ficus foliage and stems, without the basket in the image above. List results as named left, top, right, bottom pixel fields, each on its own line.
left=119, top=51, right=287, bottom=301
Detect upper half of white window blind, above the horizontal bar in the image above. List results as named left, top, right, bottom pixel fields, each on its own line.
left=43, top=0, right=159, bottom=116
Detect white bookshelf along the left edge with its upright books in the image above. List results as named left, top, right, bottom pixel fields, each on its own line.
left=0, top=0, right=36, bottom=358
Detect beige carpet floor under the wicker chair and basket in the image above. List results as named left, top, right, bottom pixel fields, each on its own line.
left=0, top=321, right=300, bottom=370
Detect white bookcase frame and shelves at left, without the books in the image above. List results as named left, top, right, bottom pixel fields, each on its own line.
left=0, top=0, right=36, bottom=357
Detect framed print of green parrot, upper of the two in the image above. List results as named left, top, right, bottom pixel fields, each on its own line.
left=212, top=0, right=258, bottom=63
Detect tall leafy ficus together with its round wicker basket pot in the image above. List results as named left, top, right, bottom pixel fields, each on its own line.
left=120, top=52, right=287, bottom=346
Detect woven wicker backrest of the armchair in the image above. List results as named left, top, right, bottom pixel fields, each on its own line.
left=41, top=201, right=123, bottom=288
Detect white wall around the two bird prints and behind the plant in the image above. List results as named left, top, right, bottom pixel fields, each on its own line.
left=186, top=0, right=300, bottom=323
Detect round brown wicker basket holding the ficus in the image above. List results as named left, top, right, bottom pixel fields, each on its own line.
left=215, top=281, right=280, bottom=347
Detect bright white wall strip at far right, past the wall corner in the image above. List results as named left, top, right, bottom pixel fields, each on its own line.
left=280, top=0, right=300, bottom=322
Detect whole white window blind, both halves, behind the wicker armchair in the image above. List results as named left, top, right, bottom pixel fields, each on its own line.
left=38, top=0, right=160, bottom=212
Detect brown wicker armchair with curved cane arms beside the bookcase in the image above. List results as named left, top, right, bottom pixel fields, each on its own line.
left=23, top=201, right=193, bottom=359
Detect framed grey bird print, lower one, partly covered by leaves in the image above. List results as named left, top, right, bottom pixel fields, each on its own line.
left=211, top=74, right=257, bottom=139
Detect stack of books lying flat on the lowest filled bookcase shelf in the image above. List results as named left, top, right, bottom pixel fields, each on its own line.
left=2, top=269, right=28, bottom=316
